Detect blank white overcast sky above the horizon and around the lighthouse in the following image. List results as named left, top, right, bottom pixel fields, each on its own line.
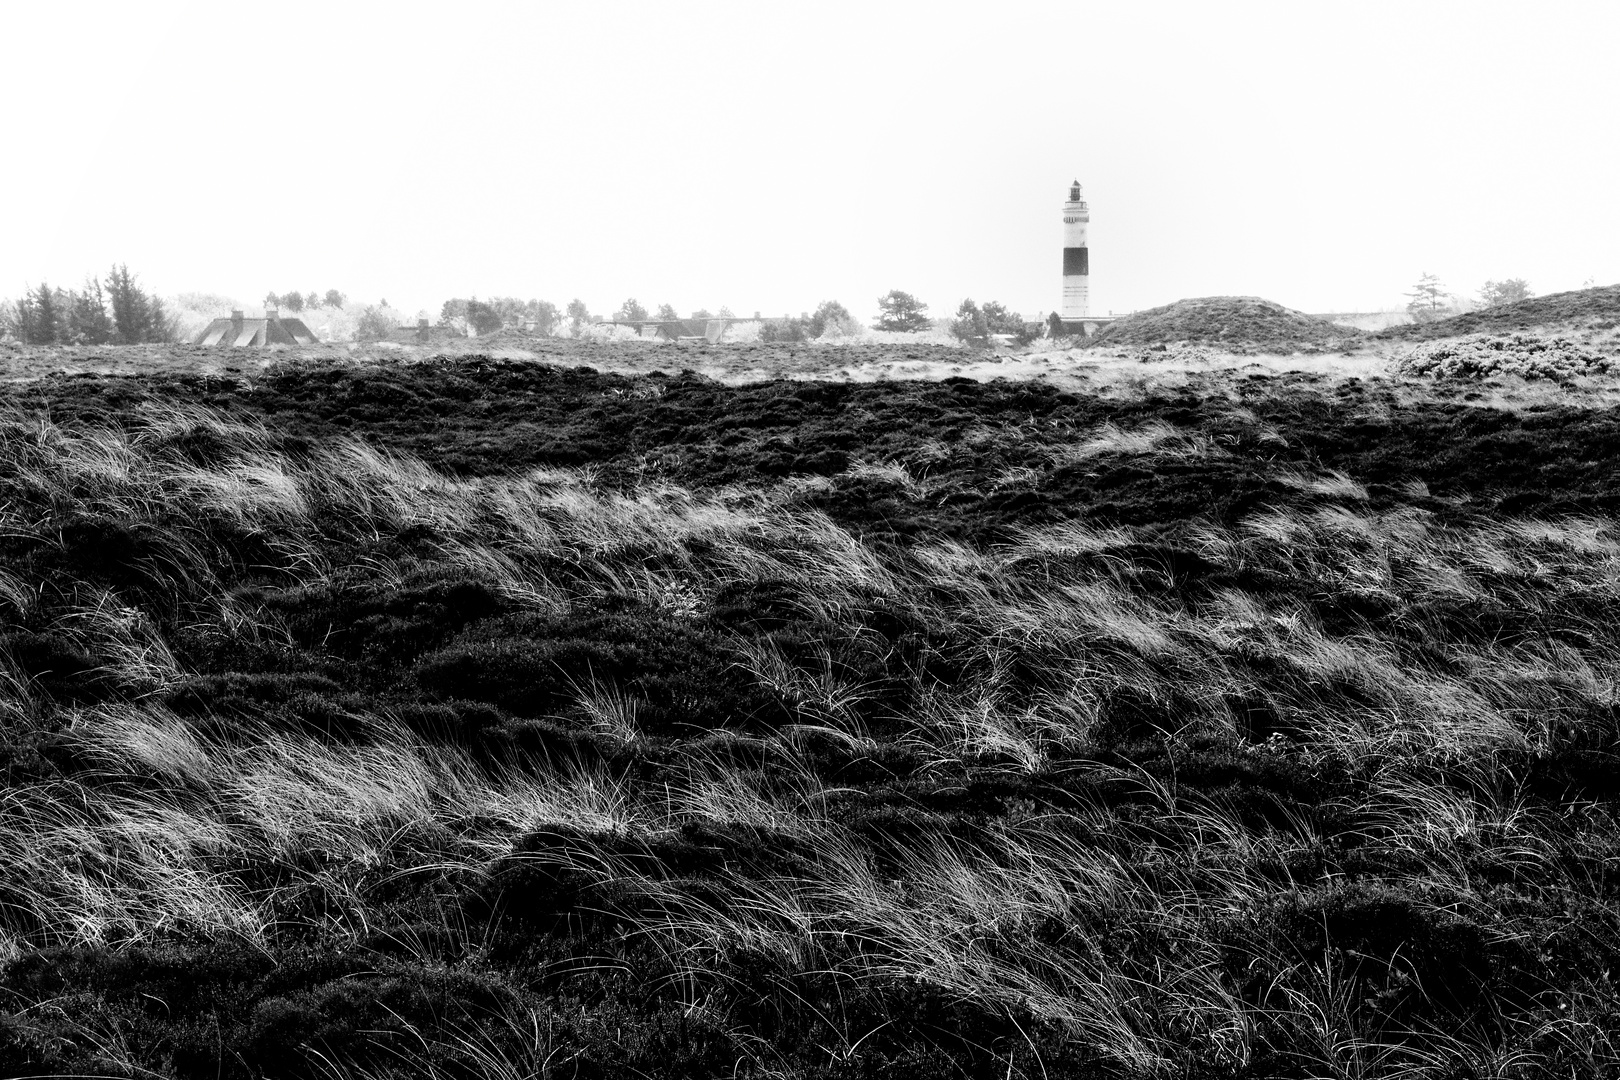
left=0, top=0, right=1620, bottom=317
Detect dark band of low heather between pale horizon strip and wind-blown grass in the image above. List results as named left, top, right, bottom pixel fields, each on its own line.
left=11, top=361, right=1620, bottom=544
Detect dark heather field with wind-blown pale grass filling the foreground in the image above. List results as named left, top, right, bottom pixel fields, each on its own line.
left=0, top=340, right=1620, bottom=1080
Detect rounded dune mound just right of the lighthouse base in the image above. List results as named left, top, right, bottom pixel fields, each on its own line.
left=1087, top=296, right=1362, bottom=353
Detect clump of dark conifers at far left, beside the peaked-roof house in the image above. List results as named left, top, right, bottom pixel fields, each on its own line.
left=0, top=264, right=178, bottom=345
